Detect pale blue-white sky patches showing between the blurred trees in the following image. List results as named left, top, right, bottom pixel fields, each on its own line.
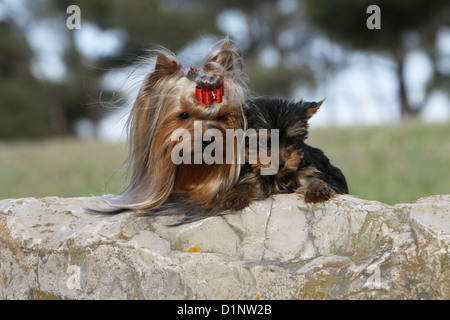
left=0, top=0, right=450, bottom=141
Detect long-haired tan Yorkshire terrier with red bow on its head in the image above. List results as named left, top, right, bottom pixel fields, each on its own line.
left=90, top=40, right=248, bottom=213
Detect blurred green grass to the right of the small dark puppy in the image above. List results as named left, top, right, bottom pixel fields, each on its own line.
left=308, top=122, right=450, bottom=204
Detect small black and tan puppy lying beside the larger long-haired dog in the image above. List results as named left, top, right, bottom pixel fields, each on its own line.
left=149, top=98, right=348, bottom=223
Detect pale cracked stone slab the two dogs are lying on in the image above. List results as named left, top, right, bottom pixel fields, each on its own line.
left=0, top=194, right=450, bottom=299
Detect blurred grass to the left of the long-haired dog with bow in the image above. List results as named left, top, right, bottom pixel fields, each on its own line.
left=0, top=139, right=126, bottom=199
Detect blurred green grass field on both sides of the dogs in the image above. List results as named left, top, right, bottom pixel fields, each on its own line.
left=0, top=122, right=450, bottom=204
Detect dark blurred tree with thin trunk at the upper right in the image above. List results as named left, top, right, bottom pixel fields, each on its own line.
left=303, top=0, right=450, bottom=118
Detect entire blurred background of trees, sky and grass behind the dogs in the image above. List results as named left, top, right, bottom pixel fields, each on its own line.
left=0, top=0, right=450, bottom=204
